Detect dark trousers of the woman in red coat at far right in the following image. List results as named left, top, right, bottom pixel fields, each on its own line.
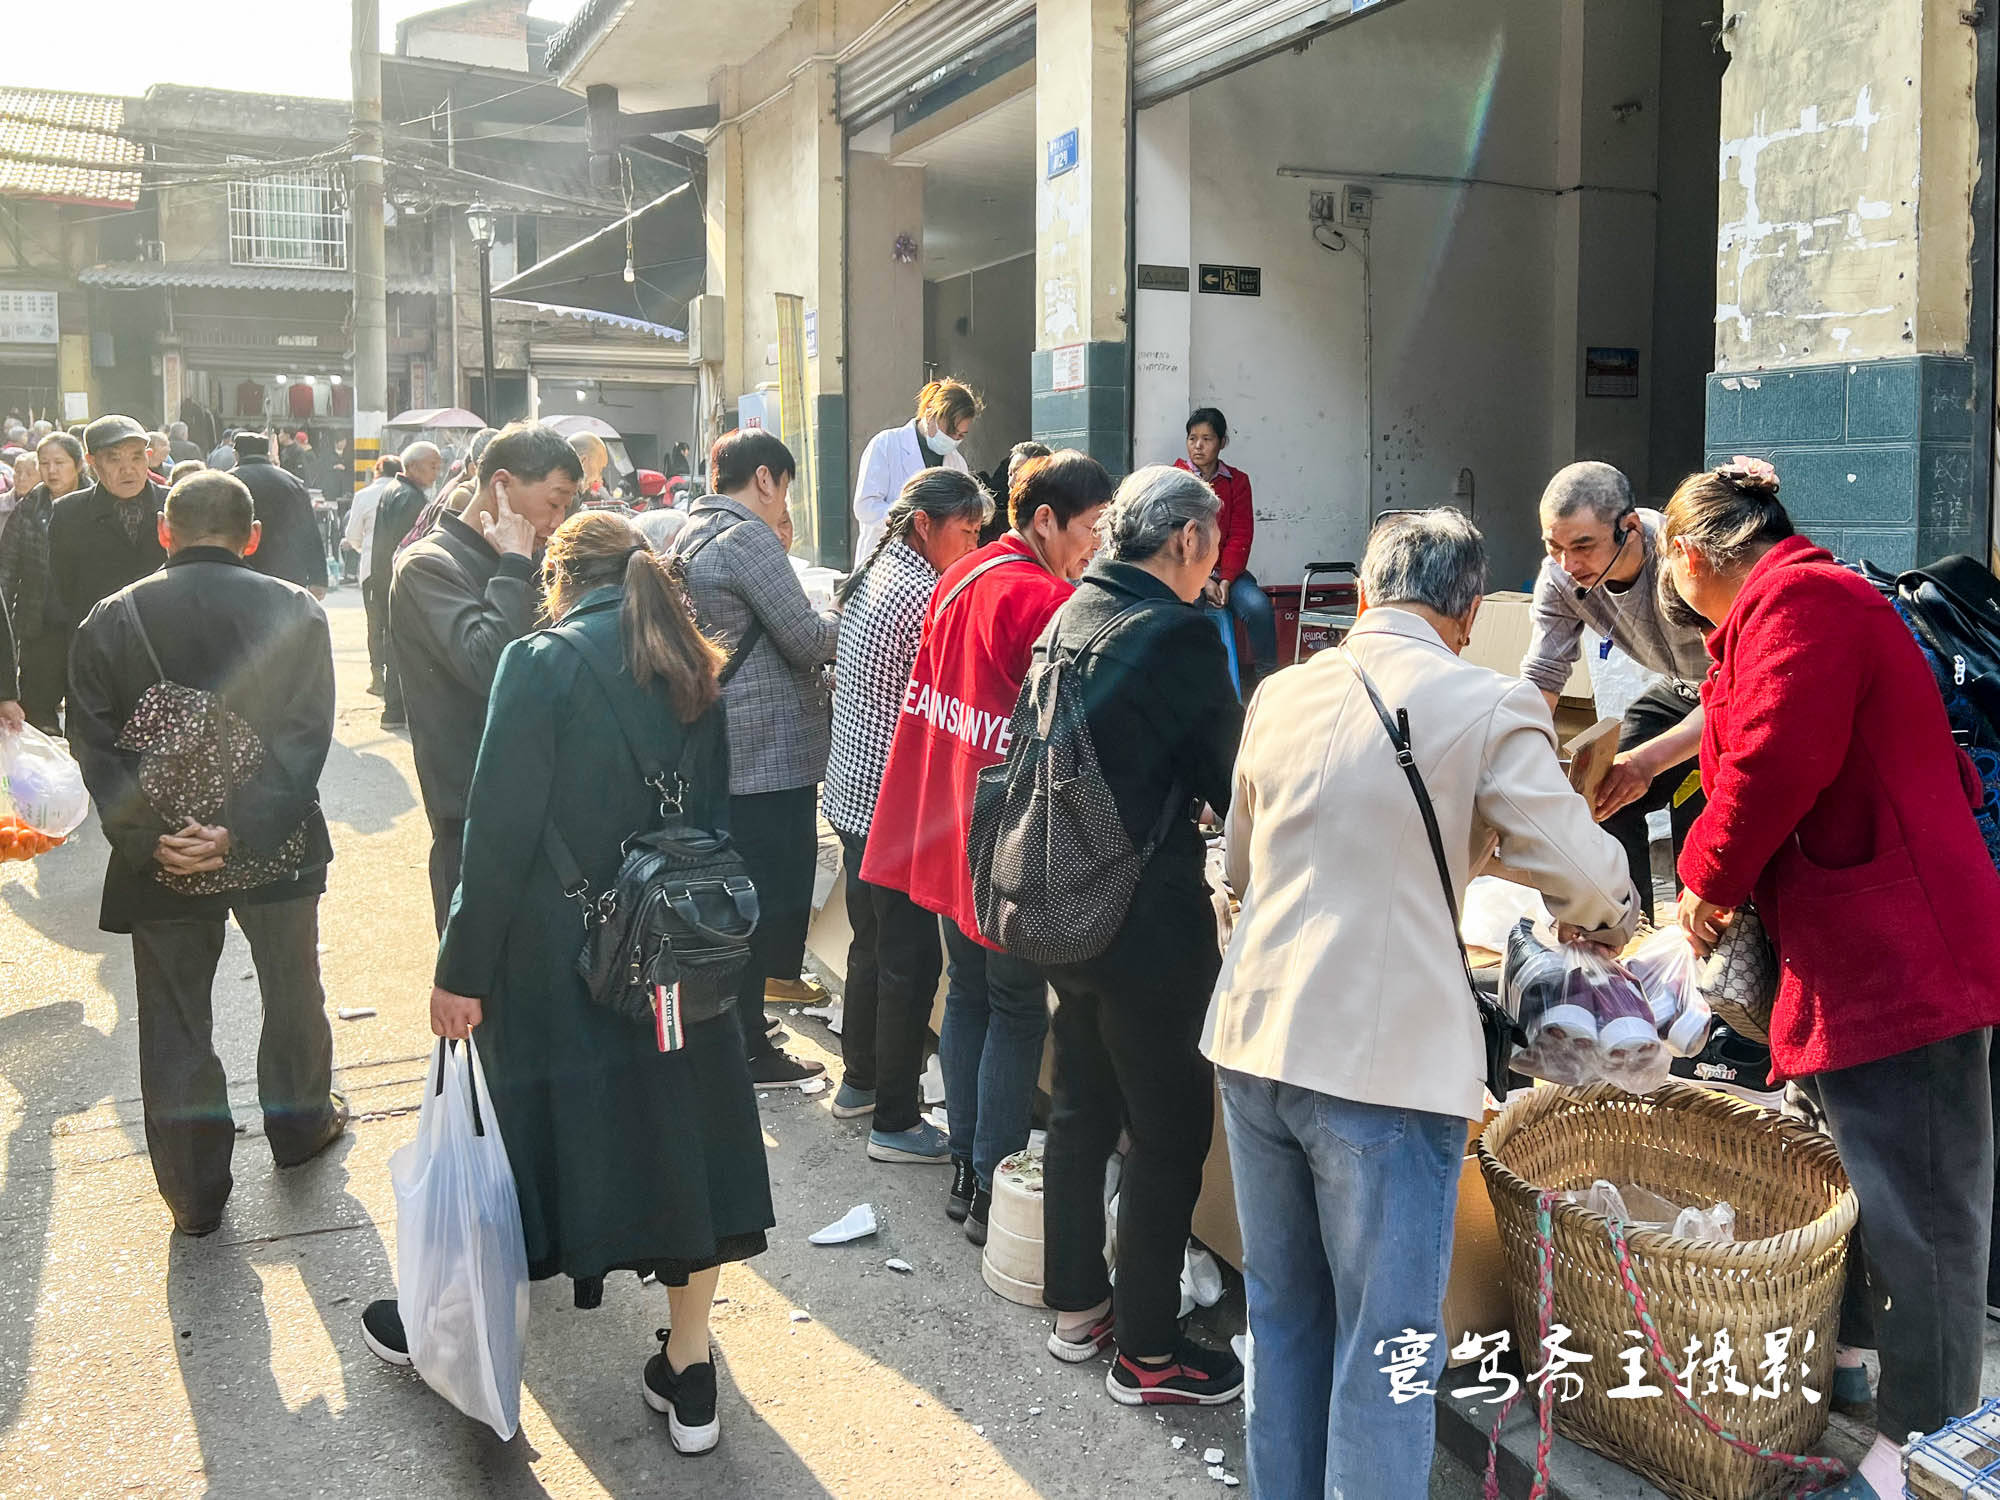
left=1804, top=1030, right=1994, bottom=1442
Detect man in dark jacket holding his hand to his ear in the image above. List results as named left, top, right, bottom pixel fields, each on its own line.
left=388, top=422, right=584, bottom=932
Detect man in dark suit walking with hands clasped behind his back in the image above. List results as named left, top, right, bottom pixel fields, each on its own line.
left=70, top=472, right=348, bottom=1234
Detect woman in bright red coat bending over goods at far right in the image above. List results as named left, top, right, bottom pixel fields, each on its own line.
left=1662, top=458, right=2000, bottom=1500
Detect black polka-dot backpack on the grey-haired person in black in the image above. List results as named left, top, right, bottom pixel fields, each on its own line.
left=966, top=600, right=1188, bottom=964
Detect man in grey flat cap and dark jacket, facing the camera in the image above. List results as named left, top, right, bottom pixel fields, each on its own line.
left=46, top=416, right=166, bottom=638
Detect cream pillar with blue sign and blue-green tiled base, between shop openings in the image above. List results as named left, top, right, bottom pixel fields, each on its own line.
left=1032, top=0, right=1132, bottom=474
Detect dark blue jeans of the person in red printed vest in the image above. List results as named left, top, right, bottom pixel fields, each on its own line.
left=938, top=916, right=1048, bottom=1188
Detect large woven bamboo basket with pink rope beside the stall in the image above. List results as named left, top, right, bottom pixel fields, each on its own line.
left=1480, top=1082, right=1856, bottom=1500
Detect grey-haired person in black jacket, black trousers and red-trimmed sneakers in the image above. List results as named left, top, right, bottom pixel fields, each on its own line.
left=1036, top=464, right=1242, bottom=1406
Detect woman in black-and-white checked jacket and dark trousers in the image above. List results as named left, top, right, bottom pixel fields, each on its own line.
left=820, top=466, right=992, bottom=1164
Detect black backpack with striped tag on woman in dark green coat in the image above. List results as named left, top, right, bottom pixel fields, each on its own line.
left=542, top=630, right=758, bottom=1052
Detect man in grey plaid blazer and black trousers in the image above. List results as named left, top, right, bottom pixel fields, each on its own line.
left=674, top=432, right=840, bottom=1088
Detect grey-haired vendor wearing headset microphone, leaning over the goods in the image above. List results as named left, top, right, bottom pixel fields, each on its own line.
left=1520, top=462, right=1708, bottom=916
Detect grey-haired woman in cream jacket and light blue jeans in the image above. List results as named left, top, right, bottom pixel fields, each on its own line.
left=1202, top=510, right=1638, bottom=1500
